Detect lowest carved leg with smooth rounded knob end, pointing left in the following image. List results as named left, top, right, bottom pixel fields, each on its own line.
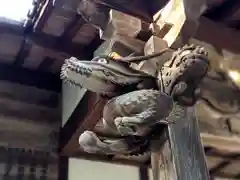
left=78, top=131, right=129, bottom=154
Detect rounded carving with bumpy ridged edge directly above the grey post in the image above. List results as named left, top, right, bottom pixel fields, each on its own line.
left=158, top=44, right=209, bottom=105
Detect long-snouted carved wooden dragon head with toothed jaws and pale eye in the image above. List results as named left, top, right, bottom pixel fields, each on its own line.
left=61, top=56, right=155, bottom=94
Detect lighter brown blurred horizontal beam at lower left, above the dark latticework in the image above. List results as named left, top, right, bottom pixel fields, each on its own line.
left=0, top=114, right=58, bottom=152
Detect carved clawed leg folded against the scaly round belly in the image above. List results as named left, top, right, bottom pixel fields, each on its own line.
left=114, top=108, right=172, bottom=135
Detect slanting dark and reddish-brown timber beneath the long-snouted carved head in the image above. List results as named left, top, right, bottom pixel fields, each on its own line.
left=60, top=92, right=106, bottom=156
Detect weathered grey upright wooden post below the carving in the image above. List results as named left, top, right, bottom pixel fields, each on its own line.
left=163, top=106, right=209, bottom=180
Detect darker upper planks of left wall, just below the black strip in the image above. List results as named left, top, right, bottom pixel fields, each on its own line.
left=0, top=81, right=59, bottom=124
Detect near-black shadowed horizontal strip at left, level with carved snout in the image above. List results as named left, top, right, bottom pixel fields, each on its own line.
left=0, top=64, right=61, bottom=92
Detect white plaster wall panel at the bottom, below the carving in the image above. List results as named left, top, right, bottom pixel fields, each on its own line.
left=68, top=158, right=139, bottom=180
